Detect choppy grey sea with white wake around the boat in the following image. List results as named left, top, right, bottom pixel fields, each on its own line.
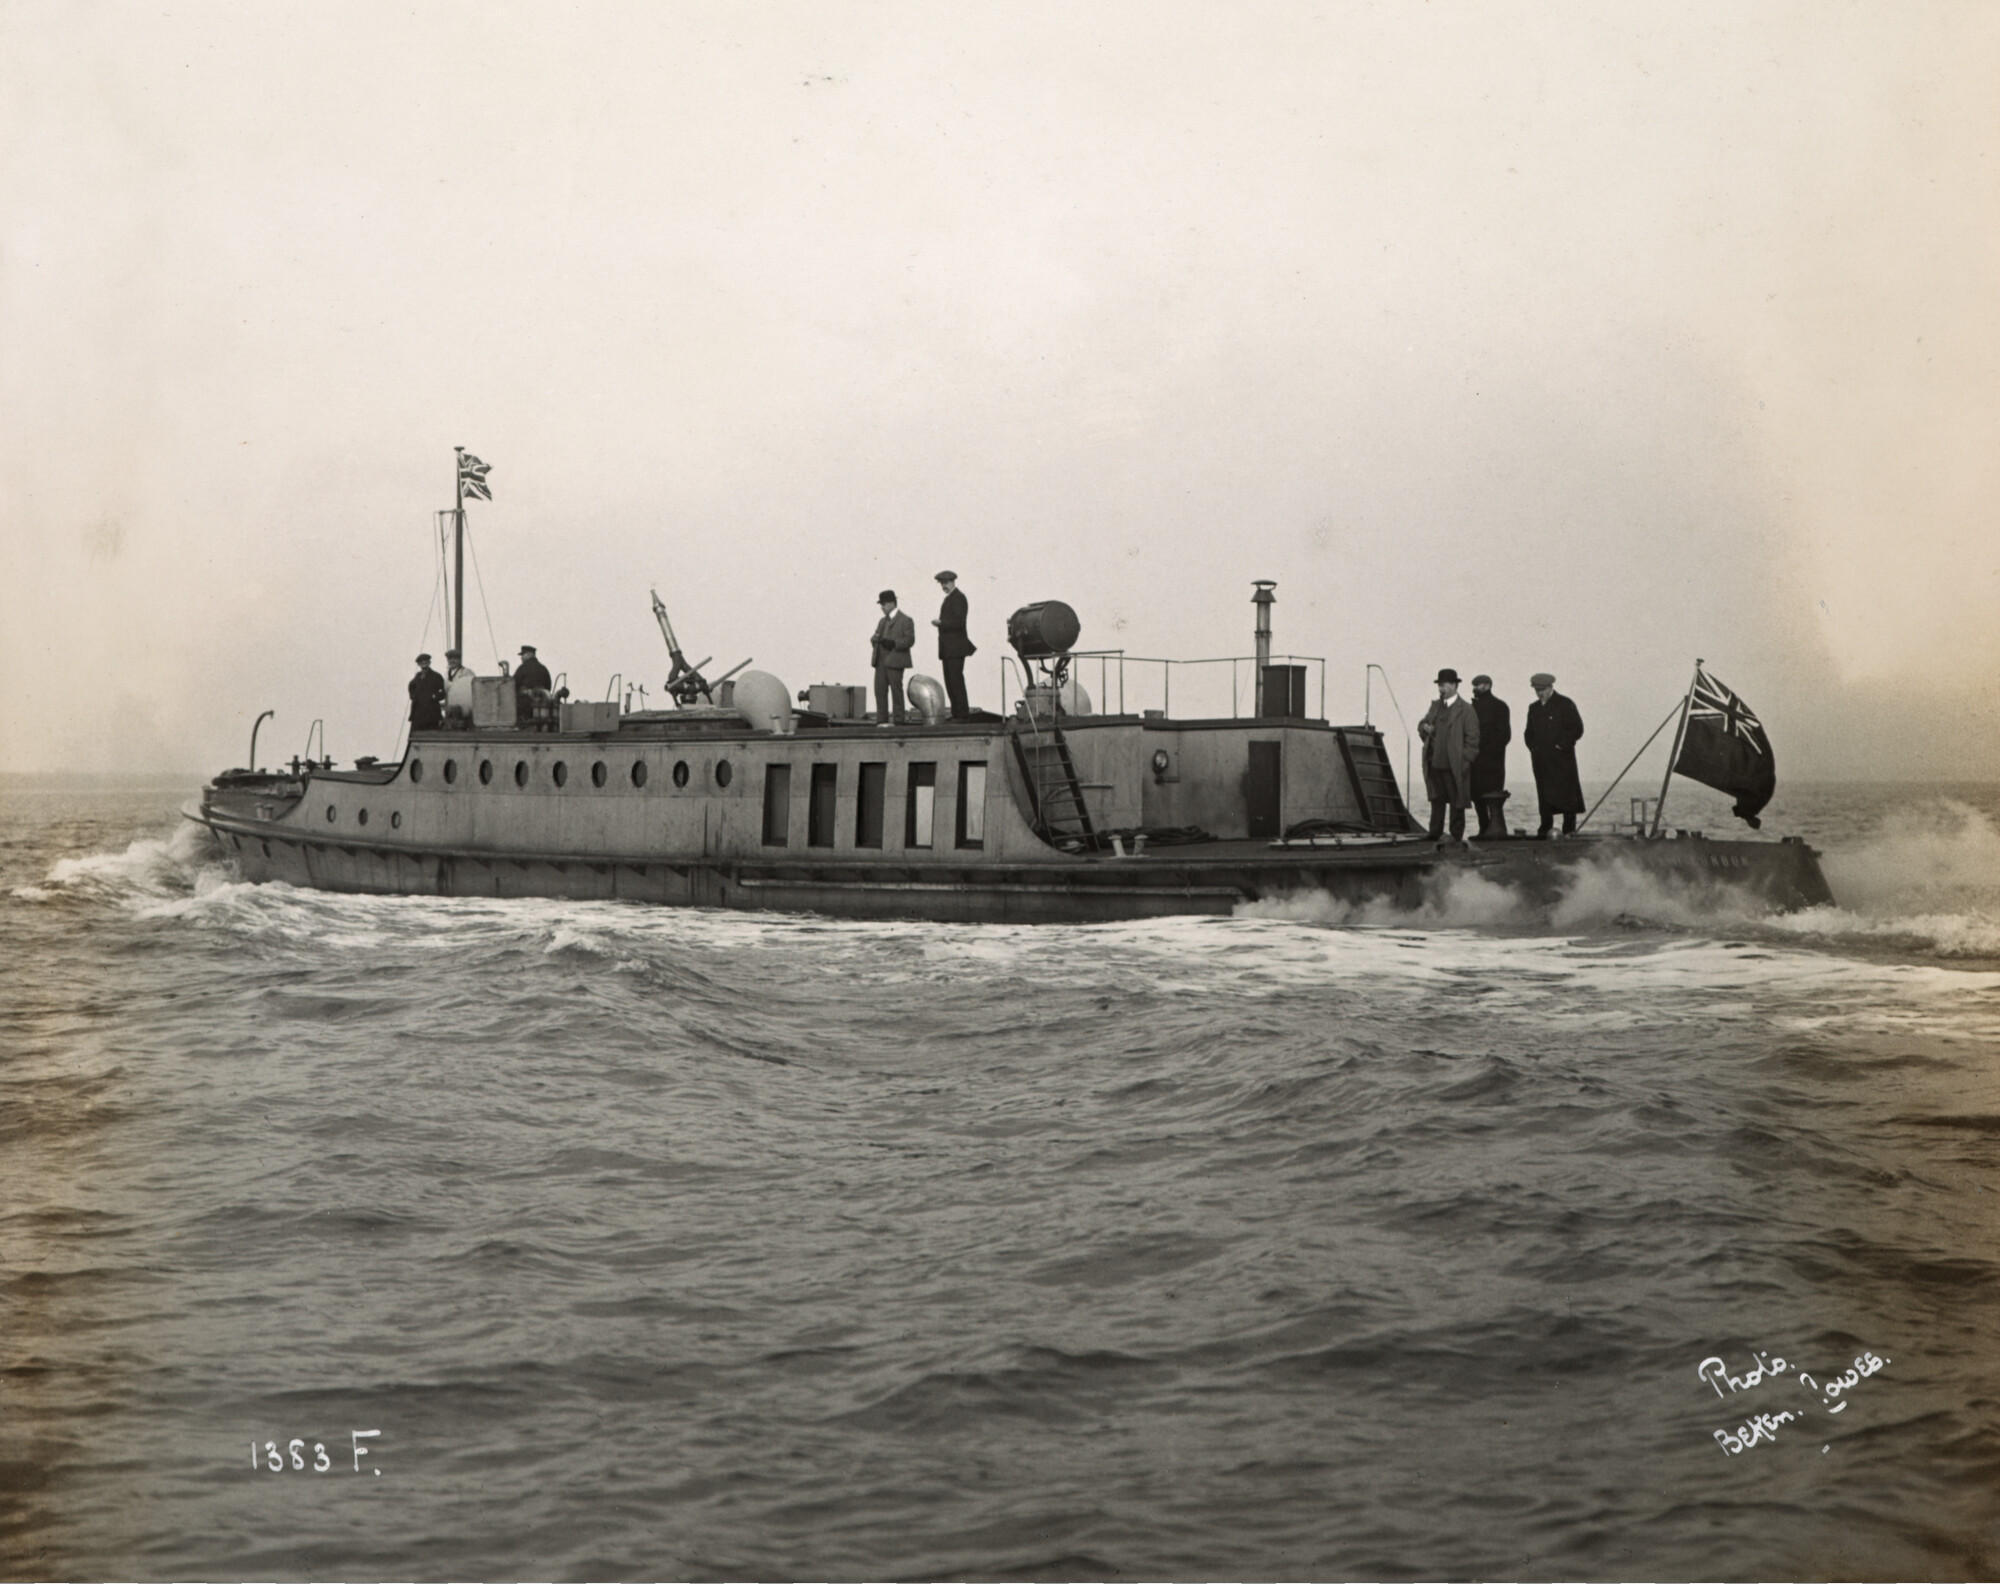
left=0, top=784, right=2000, bottom=1578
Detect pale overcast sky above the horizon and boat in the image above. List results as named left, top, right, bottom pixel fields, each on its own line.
left=0, top=0, right=2000, bottom=784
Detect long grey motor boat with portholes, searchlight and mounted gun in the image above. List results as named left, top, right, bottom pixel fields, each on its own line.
left=184, top=454, right=1832, bottom=922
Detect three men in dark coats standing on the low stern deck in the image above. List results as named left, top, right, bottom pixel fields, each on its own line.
left=1416, top=666, right=1584, bottom=842
